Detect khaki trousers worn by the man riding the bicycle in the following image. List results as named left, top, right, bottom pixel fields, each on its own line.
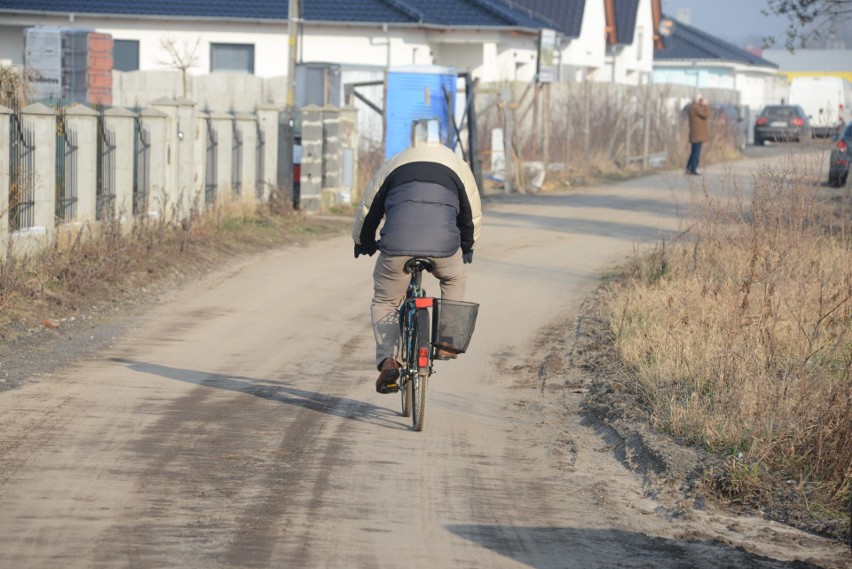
left=370, top=249, right=466, bottom=369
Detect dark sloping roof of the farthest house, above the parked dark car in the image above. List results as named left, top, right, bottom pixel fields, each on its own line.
left=654, top=15, right=778, bottom=68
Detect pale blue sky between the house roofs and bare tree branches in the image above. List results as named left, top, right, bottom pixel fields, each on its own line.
left=662, top=0, right=788, bottom=47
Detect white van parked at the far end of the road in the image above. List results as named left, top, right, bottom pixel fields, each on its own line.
left=790, top=75, right=852, bottom=137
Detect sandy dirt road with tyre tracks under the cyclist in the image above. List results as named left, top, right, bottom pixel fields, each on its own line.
left=0, top=149, right=850, bottom=569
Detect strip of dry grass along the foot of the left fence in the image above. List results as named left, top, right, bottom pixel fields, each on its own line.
left=0, top=192, right=351, bottom=341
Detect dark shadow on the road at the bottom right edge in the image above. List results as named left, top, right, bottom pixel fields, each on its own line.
left=445, top=524, right=819, bottom=569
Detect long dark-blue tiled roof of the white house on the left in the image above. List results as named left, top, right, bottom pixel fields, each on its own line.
left=0, top=0, right=551, bottom=29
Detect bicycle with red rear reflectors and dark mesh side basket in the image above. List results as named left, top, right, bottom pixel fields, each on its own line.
left=397, top=257, right=479, bottom=431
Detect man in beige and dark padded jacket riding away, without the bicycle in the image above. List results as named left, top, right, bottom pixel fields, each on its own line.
left=352, top=119, right=482, bottom=393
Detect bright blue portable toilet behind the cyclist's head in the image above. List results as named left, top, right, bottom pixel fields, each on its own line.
left=385, top=65, right=456, bottom=158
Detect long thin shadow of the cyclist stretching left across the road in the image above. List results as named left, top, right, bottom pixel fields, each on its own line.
left=110, top=358, right=408, bottom=430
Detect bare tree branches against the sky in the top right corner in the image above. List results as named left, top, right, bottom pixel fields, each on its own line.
left=763, top=0, right=852, bottom=51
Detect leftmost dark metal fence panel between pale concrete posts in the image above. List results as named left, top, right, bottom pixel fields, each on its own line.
left=9, top=113, right=35, bottom=231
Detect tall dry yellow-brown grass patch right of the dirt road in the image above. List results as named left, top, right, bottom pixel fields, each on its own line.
left=608, top=155, right=852, bottom=512
